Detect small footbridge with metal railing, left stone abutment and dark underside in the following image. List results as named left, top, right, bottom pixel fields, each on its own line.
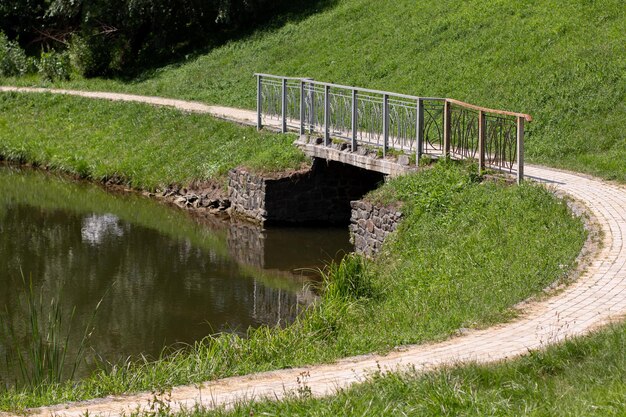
left=229, top=74, right=532, bottom=226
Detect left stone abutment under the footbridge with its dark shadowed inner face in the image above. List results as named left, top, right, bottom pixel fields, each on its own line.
left=228, top=158, right=384, bottom=225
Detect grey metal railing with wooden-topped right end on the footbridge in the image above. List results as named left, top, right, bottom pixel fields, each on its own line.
left=255, top=74, right=532, bottom=182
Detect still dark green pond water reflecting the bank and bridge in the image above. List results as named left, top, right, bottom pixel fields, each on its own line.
left=0, top=167, right=351, bottom=380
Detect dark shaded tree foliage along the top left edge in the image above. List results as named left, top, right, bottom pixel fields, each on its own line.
left=0, top=0, right=334, bottom=77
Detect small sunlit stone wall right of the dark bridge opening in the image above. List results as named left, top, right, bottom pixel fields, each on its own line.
left=350, top=200, right=402, bottom=257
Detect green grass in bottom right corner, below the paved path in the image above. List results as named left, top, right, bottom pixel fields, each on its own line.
left=196, top=324, right=626, bottom=417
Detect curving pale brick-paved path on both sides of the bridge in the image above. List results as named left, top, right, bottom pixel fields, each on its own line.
left=0, top=87, right=626, bottom=416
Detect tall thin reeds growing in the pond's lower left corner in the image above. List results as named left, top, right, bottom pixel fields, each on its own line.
left=0, top=275, right=102, bottom=390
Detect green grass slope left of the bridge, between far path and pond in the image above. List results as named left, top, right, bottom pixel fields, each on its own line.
left=0, top=93, right=305, bottom=189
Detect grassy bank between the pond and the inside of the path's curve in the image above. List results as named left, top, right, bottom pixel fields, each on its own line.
left=0, top=163, right=585, bottom=409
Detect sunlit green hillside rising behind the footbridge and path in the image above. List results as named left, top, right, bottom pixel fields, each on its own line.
left=5, top=0, right=626, bottom=181
